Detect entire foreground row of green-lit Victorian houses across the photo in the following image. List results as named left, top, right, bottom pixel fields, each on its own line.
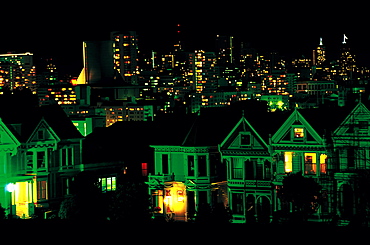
left=0, top=95, right=370, bottom=223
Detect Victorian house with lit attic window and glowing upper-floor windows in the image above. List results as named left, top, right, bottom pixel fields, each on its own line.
left=270, top=109, right=328, bottom=219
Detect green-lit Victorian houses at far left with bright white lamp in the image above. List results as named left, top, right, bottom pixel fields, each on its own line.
left=0, top=106, right=83, bottom=218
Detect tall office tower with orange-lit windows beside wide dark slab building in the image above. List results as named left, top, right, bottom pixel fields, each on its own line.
left=111, top=31, right=139, bottom=85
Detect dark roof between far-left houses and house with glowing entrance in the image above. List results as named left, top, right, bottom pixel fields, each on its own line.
left=83, top=114, right=194, bottom=163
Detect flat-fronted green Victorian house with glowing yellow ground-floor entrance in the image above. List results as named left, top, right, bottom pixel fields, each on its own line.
left=148, top=109, right=237, bottom=221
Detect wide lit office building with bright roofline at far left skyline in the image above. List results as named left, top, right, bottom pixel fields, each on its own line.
left=0, top=53, right=37, bottom=94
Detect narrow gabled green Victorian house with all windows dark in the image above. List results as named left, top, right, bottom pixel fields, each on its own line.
left=219, top=111, right=284, bottom=223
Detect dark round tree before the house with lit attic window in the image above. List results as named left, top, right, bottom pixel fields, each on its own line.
left=279, top=172, right=322, bottom=221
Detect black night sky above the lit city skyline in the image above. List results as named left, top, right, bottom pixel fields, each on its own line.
left=0, top=2, right=370, bottom=75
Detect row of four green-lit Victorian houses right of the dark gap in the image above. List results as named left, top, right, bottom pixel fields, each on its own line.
left=148, top=99, right=370, bottom=223
